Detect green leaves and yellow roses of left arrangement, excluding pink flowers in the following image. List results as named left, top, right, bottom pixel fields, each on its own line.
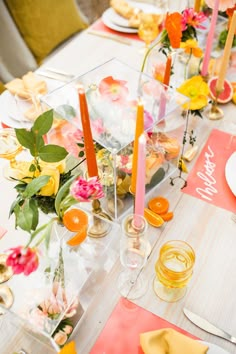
left=10, top=110, right=86, bottom=249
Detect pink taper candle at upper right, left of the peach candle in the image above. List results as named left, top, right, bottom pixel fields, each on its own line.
left=201, top=0, right=220, bottom=76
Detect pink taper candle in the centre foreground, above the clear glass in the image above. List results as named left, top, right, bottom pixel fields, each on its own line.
left=134, top=134, right=146, bottom=226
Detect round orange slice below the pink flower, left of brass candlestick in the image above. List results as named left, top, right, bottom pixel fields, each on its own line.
left=63, top=209, right=88, bottom=232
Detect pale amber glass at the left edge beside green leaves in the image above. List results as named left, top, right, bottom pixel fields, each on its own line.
left=0, top=128, right=23, bottom=179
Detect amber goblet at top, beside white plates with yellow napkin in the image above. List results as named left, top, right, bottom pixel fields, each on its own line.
left=138, top=13, right=159, bottom=50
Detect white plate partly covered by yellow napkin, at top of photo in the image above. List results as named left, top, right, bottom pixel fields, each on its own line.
left=102, top=1, right=162, bottom=33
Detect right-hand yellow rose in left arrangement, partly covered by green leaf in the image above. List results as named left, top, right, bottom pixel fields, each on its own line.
left=39, top=164, right=60, bottom=197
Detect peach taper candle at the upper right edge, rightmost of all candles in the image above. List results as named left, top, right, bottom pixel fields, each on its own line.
left=216, top=11, right=236, bottom=93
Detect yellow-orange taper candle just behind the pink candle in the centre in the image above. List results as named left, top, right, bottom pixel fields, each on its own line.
left=130, top=101, right=144, bottom=194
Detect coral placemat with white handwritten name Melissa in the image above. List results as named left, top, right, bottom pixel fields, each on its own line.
left=182, top=129, right=236, bottom=212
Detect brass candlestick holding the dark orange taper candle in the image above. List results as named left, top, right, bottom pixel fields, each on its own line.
left=88, top=199, right=112, bottom=238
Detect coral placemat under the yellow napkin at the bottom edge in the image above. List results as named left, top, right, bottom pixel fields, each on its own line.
left=90, top=298, right=197, bottom=354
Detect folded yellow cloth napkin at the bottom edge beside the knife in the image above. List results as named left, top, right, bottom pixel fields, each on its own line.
left=140, top=328, right=208, bottom=354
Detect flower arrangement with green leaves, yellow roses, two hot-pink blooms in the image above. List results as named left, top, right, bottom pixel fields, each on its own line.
left=7, top=110, right=104, bottom=275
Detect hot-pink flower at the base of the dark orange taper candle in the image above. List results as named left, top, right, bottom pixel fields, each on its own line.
left=70, top=177, right=104, bottom=202
